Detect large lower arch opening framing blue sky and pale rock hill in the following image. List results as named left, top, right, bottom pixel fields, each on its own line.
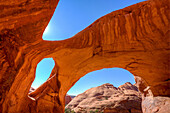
left=65, top=68, right=142, bottom=113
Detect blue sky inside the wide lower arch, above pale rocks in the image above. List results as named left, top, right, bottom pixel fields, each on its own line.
left=68, top=68, right=135, bottom=95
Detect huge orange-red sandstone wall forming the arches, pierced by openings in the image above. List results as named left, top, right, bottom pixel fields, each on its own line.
left=0, top=0, right=170, bottom=113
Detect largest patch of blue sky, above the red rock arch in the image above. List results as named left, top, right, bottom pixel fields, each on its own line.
left=43, top=0, right=144, bottom=40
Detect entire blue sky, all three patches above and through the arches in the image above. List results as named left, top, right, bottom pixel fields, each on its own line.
left=32, top=0, right=145, bottom=95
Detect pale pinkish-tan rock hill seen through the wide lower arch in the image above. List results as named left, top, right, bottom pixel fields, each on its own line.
left=66, top=82, right=142, bottom=113
